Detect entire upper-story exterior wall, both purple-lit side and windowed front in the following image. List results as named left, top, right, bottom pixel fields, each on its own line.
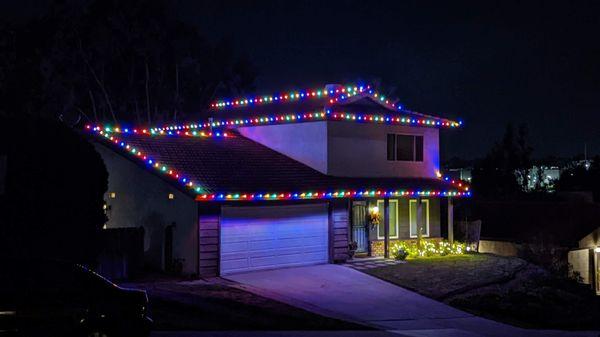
left=238, top=121, right=439, bottom=178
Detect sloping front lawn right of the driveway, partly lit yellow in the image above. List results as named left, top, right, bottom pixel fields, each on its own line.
left=366, top=254, right=600, bottom=330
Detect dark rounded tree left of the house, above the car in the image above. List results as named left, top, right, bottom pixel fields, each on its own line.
left=0, top=116, right=108, bottom=263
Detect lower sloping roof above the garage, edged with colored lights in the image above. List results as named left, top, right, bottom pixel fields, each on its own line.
left=90, top=128, right=470, bottom=200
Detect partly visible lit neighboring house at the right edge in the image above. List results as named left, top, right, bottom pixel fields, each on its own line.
left=568, top=227, right=600, bottom=295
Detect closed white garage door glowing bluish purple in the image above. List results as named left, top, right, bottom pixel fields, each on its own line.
left=221, top=204, right=329, bottom=275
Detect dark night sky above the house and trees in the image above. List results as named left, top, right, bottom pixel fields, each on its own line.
left=3, top=0, right=600, bottom=159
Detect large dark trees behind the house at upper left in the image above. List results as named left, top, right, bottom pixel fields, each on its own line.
left=0, top=0, right=256, bottom=124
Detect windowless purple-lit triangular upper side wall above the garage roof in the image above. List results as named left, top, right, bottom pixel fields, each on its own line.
left=238, top=121, right=327, bottom=173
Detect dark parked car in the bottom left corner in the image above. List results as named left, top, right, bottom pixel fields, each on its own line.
left=0, top=260, right=152, bottom=337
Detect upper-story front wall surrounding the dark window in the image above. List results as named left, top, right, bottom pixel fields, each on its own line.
left=327, top=122, right=440, bottom=178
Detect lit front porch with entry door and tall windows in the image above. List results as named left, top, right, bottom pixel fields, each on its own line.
left=348, top=197, right=454, bottom=258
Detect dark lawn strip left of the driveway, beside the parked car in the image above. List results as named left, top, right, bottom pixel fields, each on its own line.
left=127, top=281, right=370, bottom=331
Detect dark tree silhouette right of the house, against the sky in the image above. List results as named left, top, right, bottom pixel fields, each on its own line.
left=473, top=124, right=532, bottom=197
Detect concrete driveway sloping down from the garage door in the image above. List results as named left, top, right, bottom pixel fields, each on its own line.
left=227, top=264, right=598, bottom=337
